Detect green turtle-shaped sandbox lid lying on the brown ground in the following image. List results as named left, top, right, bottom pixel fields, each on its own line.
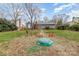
left=37, top=38, right=53, bottom=46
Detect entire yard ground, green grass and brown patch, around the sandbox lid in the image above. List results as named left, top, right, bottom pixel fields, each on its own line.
left=0, top=30, right=79, bottom=56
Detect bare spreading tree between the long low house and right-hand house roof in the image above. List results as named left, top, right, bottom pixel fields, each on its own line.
left=53, top=14, right=69, bottom=25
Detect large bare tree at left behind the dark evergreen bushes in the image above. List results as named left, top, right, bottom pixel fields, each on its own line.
left=0, top=3, right=23, bottom=29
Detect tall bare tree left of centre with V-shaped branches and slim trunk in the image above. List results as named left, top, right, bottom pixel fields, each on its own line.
left=24, top=3, right=41, bottom=28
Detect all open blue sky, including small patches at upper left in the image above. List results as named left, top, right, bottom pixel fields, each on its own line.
left=0, top=3, right=79, bottom=19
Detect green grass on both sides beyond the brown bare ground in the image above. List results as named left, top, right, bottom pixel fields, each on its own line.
left=0, top=30, right=79, bottom=42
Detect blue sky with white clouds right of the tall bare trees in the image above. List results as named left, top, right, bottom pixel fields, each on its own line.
left=39, top=3, right=79, bottom=18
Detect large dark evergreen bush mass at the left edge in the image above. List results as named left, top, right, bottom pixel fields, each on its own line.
left=0, top=18, right=17, bottom=32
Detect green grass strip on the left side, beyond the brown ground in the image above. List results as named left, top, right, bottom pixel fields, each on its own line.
left=0, top=31, right=26, bottom=42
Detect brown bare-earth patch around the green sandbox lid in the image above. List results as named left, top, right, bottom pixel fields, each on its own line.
left=0, top=34, right=79, bottom=56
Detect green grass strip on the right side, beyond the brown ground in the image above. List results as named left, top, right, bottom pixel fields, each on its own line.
left=45, top=30, right=79, bottom=42
